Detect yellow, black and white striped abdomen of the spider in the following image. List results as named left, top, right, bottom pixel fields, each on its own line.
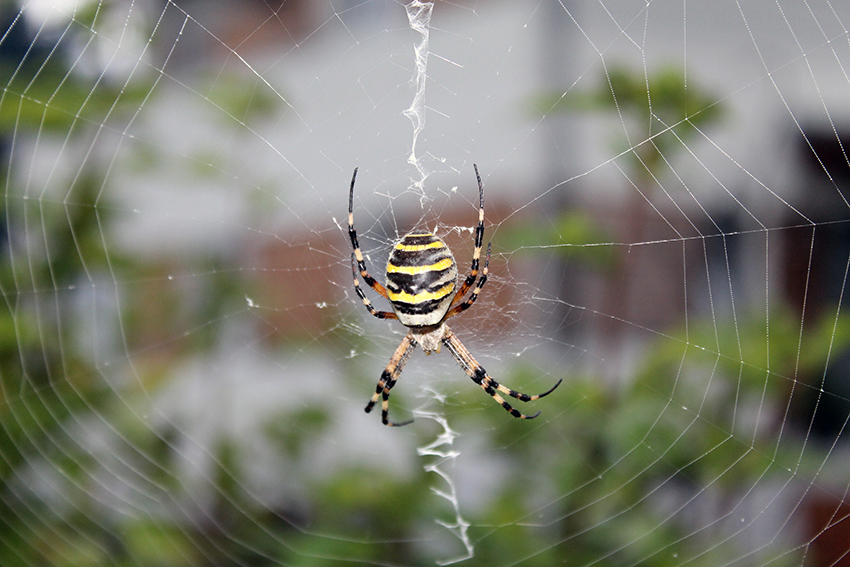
left=387, top=232, right=457, bottom=327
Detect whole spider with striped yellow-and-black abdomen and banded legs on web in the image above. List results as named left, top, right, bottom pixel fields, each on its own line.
left=348, top=164, right=561, bottom=427
